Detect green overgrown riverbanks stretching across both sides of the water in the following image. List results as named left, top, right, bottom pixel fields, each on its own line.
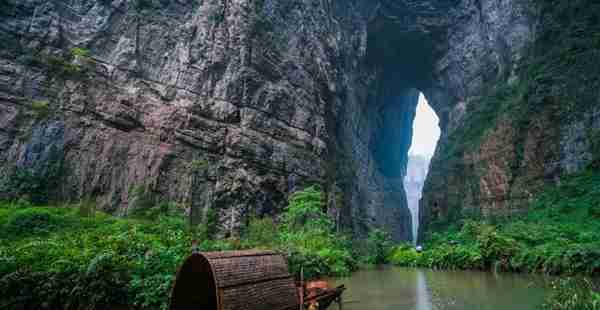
left=0, top=172, right=600, bottom=309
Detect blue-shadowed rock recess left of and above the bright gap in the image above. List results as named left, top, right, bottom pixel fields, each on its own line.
left=334, top=1, right=458, bottom=241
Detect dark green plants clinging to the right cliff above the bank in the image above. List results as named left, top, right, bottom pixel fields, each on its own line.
left=428, top=0, right=600, bottom=237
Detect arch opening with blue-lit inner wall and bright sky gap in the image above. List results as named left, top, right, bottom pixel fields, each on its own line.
left=363, top=83, right=443, bottom=242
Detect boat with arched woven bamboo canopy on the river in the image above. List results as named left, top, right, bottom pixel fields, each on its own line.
left=169, top=251, right=344, bottom=310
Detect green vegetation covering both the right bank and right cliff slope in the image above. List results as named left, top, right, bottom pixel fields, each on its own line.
left=388, top=0, right=600, bottom=309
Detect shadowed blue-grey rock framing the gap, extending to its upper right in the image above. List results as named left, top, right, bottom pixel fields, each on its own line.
left=330, top=1, right=535, bottom=240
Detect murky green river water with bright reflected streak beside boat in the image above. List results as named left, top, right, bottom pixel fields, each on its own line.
left=335, top=267, right=546, bottom=310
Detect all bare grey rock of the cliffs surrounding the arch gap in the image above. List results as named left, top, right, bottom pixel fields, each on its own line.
left=0, top=0, right=598, bottom=240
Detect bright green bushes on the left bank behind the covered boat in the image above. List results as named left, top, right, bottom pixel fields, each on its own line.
left=0, top=187, right=366, bottom=309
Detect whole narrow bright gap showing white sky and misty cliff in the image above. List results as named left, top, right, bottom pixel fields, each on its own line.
left=404, top=93, right=441, bottom=244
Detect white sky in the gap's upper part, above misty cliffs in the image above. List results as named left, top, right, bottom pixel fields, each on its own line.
left=408, top=93, right=440, bottom=157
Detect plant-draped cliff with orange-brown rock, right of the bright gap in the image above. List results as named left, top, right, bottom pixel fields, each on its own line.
left=421, top=1, right=600, bottom=240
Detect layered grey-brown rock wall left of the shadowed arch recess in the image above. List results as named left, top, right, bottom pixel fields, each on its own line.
left=0, top=0, right=336, bottom=232
